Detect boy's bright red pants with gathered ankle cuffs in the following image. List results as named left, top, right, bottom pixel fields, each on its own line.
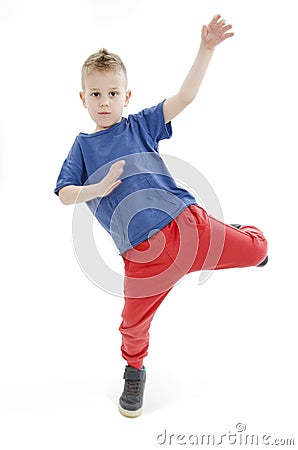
left=120, top=205, right=267, bottom=369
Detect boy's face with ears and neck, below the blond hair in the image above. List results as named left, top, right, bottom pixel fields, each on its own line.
left=80, top=70, right=131, bottom=132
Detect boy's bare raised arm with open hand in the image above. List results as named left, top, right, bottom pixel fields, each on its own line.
left=163, top=14, right=234, bottom=123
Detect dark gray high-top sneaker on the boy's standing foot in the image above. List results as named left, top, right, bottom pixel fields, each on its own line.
left=118, top=366, right=146, bottom=417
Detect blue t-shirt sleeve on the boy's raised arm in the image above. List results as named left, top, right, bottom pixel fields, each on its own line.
left=137, top=100, right=172, bottom=143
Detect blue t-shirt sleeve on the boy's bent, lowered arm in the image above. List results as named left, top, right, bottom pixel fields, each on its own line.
left=54, top=140, right=86, bottom=195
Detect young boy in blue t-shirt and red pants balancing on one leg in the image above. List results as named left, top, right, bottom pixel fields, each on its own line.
left=55, top=15, right=267, bottom=417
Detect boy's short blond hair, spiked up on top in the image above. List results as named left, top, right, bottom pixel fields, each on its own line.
left=81, top=48, right=127, bottom=90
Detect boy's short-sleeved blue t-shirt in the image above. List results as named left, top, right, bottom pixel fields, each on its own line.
left=54, top=102, right=196, bottom=254
